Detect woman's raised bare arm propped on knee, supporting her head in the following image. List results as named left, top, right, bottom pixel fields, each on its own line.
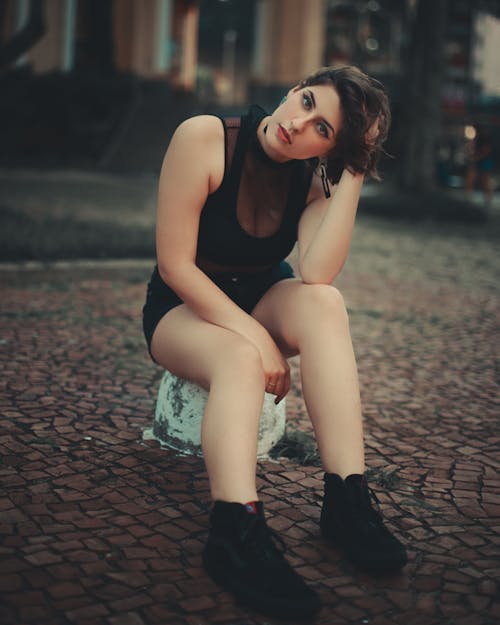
left=298, top=169, right=364, bottom=284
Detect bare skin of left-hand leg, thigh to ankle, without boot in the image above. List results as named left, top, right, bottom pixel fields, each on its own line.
left=151, top=305, right=265, bottom=503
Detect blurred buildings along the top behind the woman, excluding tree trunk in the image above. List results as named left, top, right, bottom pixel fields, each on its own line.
left=0, top=0, right=500, bottom=180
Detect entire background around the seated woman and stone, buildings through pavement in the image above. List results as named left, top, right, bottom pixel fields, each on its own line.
left=0, top=0, right=500, bottom=625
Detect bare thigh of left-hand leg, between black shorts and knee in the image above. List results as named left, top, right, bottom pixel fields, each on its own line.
left=151, top=304, right=255, bottom=390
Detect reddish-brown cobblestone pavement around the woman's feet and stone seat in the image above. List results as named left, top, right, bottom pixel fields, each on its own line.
left=0, top=218, right=500, bottom=625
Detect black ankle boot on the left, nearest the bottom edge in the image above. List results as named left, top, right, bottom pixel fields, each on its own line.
left=203, top=501, right=320, bottom=618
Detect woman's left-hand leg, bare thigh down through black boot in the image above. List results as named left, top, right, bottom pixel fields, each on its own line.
left=151, top=305, right=320, bottom=617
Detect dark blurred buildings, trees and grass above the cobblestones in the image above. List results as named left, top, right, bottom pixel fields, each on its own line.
left=0, top=0, right=500, bottom=261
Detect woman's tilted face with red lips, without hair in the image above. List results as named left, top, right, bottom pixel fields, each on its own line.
left=258, top=85, right=342, bottom=161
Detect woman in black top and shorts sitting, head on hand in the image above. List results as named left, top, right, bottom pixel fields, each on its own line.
left=144, top=67, right=406, bottom=617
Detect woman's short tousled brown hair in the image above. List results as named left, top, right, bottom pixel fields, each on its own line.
left=299, top=65, right=391, bottom=182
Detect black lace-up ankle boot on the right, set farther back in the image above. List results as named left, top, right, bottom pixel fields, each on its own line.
left=320, top=473, right=408, bottom=574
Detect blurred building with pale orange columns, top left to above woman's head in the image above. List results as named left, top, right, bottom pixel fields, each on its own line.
left=0, top=0, right=326, bottom=103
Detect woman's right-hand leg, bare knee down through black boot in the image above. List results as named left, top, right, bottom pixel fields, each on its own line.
left=252, top=281, right=407, bottom=573
